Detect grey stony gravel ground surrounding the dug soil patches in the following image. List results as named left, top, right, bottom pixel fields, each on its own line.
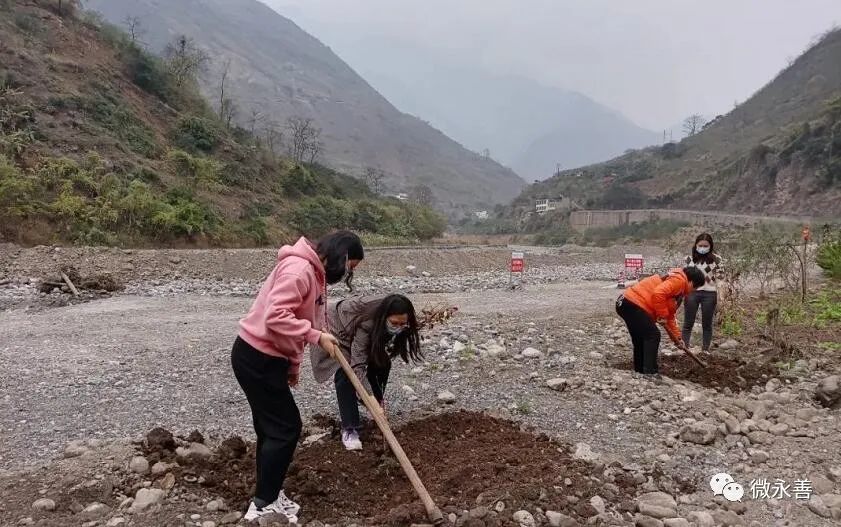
left=0, top=245, right=841, bottom=527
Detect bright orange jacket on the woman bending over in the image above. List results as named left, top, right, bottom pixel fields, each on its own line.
left=625, top=269, right=693, bottom=342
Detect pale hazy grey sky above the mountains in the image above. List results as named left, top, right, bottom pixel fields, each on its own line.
left=263, top=0, right=841, bottom=130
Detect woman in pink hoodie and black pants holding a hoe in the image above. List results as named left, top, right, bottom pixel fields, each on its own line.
left=231, top=231, right=364, bottom=523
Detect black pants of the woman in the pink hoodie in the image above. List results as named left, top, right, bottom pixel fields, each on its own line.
left=231, top=337, right=301, bottom=503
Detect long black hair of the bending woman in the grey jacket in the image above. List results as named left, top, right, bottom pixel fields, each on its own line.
left=369, top=295, right=423, bottom=367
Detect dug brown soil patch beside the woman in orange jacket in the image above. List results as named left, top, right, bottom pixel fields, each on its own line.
left=613, top=353, right=780, bottom=392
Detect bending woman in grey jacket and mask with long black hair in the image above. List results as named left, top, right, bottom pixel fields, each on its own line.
left=310, top=295, right=423, bottom=450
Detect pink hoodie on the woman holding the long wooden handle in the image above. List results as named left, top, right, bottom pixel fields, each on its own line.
left=239, top=238, right=327, bottom=374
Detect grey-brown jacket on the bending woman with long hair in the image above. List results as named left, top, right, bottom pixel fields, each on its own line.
left=310, top=295, right=387, bottom=393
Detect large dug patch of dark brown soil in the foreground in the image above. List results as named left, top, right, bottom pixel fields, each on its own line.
left=147, top=412, right=644, bottom=526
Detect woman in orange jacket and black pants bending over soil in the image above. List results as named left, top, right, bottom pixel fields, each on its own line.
left=616, top=267, right=705, bottom=374
